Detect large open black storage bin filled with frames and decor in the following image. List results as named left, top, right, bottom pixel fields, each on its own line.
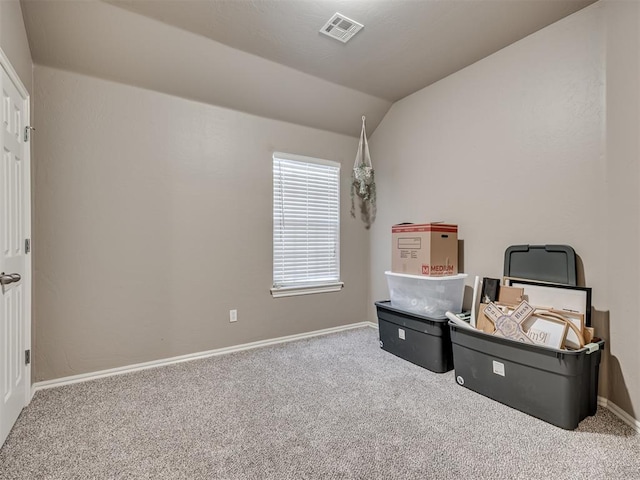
left=449, top=323, right=604, bottom=430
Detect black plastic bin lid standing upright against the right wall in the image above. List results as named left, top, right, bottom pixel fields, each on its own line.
left=504, top=245, right=578, bottom=285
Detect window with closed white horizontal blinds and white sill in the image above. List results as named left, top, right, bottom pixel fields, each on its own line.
left=271, top=152, right=343, bottom=297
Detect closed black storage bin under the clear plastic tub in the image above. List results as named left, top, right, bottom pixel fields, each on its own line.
left=376, top=301, right=453, bottom=373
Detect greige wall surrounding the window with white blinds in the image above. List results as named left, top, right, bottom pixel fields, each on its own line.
left=34, top=66, right=369, bottom=380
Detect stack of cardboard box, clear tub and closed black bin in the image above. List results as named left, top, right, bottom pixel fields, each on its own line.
left=376, top=223, right=466, bottom=373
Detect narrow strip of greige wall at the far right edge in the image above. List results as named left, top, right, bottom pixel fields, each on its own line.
left=594, top=0, right=640, bottom=420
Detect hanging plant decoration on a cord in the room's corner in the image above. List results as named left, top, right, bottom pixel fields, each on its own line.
left=351, top=115, right=376, bottom=230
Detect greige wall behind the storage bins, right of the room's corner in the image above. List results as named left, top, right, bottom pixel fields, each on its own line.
left=369, top=2, right=640, bottom=417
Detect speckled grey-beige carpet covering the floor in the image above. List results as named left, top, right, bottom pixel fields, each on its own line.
left=0, top=328, right=640, bottom=480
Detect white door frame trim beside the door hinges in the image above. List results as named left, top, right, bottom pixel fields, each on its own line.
left=0, top=48, right=33, bottom=408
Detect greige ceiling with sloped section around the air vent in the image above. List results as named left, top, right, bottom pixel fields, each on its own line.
left=22, top=0, right=594, bottom=135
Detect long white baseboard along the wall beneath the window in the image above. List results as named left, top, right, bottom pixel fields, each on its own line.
left=29, top=322, right=372, bottom=394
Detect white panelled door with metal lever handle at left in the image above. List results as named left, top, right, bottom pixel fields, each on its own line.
left=0, top=54, right=31, bottom=446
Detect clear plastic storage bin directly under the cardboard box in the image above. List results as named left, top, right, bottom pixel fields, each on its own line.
left=385, top=272, right=467, bottom=318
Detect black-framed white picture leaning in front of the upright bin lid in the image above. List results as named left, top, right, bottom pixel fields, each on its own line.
left=504, top=277, right=591, bottom=330
